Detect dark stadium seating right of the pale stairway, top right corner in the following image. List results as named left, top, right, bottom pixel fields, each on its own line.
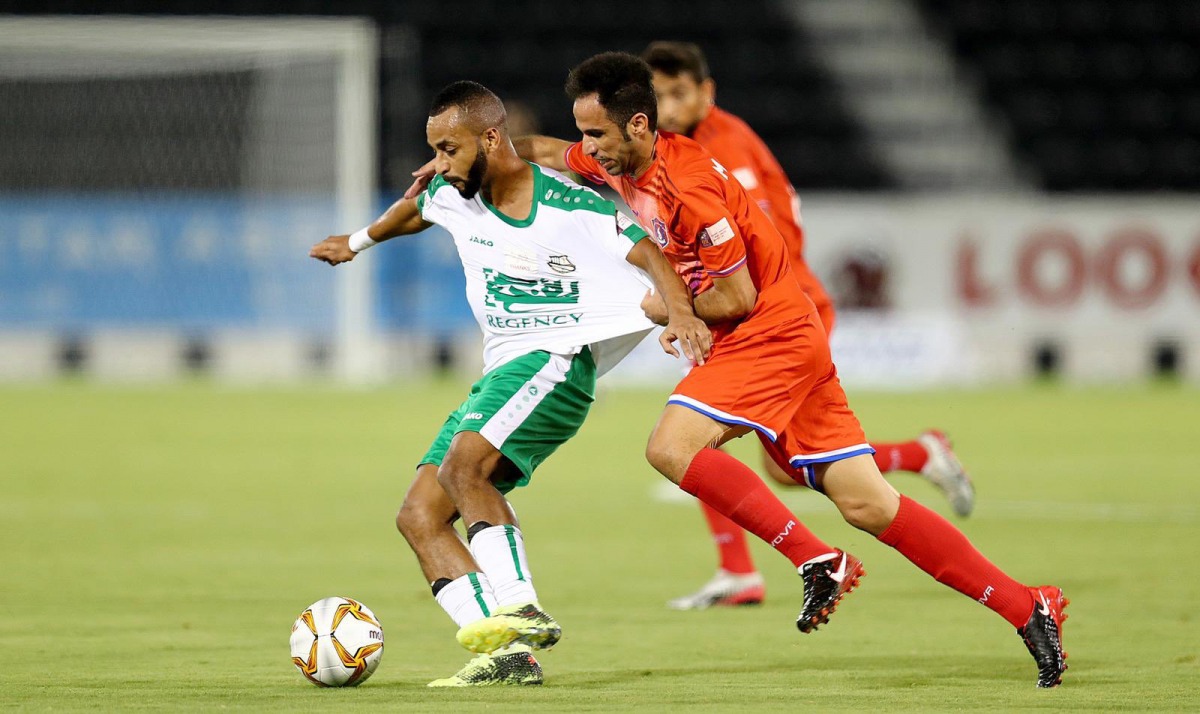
left=920, top=0, right=1200, bottom=192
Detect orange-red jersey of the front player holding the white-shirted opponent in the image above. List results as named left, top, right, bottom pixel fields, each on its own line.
left=565, top=131, right=815, bottom=340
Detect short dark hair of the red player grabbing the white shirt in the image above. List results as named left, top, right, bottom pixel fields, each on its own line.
left=566, top=52, right=659, bottom=133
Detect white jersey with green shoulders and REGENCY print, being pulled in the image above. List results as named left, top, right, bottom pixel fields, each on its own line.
left=416, top=164, right=654, bottom=373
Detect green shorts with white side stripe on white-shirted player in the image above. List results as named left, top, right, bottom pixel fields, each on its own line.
left=418, top=347, right=596, bottom=493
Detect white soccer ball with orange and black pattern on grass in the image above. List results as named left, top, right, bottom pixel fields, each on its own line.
left=292, top=598, right=383, bottom=686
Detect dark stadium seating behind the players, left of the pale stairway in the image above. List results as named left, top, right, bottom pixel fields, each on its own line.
left=7, top=0, right=895, bottom=192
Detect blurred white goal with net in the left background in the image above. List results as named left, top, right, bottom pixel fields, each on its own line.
left=0, top=17, right=382, bottom=382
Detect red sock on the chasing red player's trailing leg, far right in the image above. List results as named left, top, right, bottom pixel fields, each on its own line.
left=878, top=496, right=1033, bottom=628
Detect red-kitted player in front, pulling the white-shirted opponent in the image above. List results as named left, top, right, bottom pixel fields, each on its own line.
left=515, top=53, right=1067, bottom=686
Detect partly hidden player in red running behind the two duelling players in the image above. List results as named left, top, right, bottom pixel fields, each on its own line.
left=642, top=42, right=974, bottom=610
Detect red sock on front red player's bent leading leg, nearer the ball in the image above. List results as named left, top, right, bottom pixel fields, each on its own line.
left=679, top=449, right=833, bottom=568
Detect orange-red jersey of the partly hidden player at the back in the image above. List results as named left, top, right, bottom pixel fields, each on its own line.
left=691, top=107, right=832, bottom=316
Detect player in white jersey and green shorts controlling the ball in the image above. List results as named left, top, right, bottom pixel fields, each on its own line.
left=310, top=82, right=712, bottom=686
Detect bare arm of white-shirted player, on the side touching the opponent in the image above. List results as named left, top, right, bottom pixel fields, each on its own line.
left=625, top=238, right=713, bottom=365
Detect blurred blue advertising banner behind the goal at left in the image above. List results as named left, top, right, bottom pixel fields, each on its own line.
left=0, top=194, right=473, bottom=334
